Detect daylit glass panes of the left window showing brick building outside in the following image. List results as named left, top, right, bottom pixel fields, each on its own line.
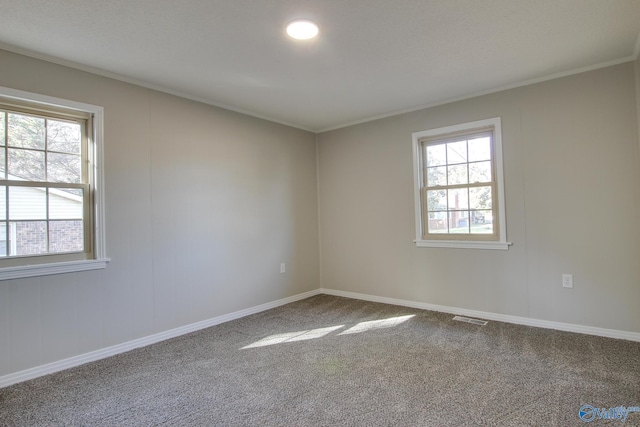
left=0, top=106, right=91, bottom=257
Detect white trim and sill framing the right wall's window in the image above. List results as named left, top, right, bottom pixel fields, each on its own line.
left=411, top=117, right=512, bottom=250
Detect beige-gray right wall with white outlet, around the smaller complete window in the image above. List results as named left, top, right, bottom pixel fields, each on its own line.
left=318, top=62, right=640, bottom=332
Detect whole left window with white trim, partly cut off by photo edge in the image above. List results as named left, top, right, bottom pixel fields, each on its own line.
left=0, top=87, right=108, bottom=279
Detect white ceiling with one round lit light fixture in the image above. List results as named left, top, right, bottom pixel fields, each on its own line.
left=0, top=0, right=640, bottom=131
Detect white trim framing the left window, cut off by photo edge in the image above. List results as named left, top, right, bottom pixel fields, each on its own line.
left=0, top=86, right=110, bottom=280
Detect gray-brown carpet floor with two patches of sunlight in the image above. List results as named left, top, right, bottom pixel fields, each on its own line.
left=0, top=295, right=640, bottom=426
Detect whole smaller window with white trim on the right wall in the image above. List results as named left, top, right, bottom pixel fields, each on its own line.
left=413, top=118, right=509, bottom=249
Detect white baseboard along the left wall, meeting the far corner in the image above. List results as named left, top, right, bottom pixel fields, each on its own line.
left=0, top=289, right=320, bottom=388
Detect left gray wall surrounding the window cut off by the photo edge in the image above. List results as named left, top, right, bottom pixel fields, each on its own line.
left=0, top=51, right=319, bottom=376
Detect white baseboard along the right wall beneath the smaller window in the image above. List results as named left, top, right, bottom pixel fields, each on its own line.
left=320, top=288, right=640, bottom=342
